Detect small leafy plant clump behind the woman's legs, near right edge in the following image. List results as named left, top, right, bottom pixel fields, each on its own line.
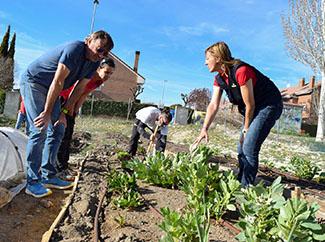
left=290, top=157, right=321, bottom=180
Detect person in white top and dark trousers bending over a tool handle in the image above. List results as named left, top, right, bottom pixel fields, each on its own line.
left=128, top=107, right=172, bottom=157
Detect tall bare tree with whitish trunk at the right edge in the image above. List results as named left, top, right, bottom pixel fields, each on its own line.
left=281, top=0, right=325, bottom=141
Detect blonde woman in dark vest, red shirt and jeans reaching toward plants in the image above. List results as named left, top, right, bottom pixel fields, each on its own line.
left=193, top=42, right=283, bottom=188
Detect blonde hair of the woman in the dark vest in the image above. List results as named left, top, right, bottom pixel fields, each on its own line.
left=205, top=41, right=241, bottom=73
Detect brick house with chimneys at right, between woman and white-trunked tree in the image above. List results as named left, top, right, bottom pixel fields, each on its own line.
left=280, top=76, right=321, bottom=123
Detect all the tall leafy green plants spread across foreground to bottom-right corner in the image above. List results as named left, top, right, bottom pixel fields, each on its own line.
left=123, top=146, right=325, bottom=242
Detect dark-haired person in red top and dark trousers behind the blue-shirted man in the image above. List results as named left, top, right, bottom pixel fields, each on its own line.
left=56, top=58, right=115, bottom=181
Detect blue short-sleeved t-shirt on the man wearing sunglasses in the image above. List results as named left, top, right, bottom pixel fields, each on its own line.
left=22, top=40, right=100, bottom=90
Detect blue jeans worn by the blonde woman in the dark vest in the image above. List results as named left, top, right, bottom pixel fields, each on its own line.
left=237, top=101, right=283, bottom=188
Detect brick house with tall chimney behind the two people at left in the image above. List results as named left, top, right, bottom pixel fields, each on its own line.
left=93, top=51, right=145, bottom=102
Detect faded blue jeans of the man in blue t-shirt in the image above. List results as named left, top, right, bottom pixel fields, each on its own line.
left=20, top=80, right=64, bottom=185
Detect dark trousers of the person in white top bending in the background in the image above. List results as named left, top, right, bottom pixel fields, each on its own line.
left=128, top=119, right=167, bottom=156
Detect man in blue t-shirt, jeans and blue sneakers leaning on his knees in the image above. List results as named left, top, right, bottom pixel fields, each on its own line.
left=20, top=31, right=114, bottom=197
